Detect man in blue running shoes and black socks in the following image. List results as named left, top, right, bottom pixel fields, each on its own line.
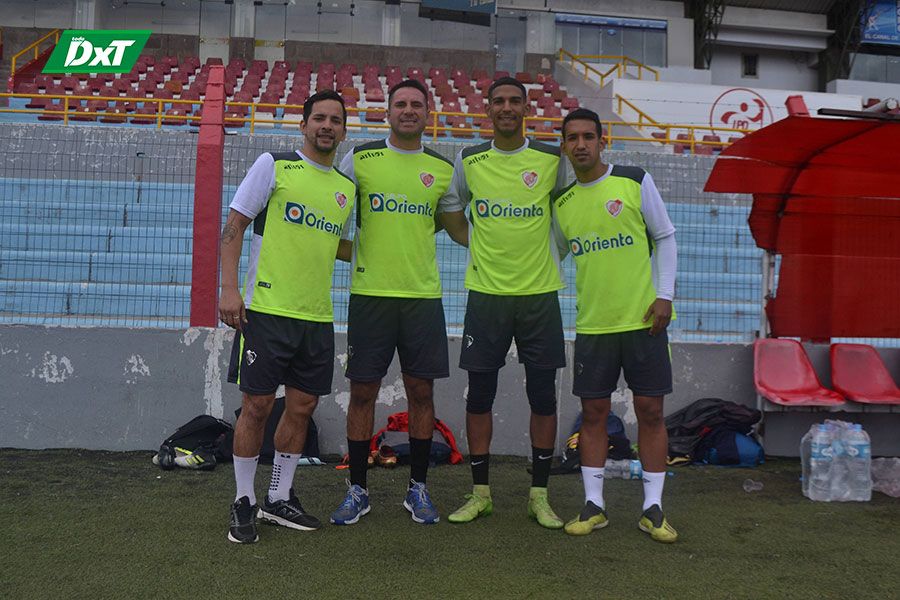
left=331, top=80, right=468, bottom=525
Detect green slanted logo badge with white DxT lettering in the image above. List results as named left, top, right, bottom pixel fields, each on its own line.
left=43, top=29, right=151, bottom=73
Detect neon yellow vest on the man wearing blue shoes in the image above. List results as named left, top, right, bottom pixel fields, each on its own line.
left=350, top=140, right=453, bottom=298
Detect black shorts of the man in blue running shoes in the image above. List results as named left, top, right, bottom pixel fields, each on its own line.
left=346, top=294, right=450, bottom=382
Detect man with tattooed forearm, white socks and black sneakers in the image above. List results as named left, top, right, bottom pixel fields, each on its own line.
left=219, top=91, right=356, bottom=543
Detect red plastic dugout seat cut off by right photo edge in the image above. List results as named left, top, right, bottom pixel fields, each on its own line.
left=831, top=344, right=900, bottom=404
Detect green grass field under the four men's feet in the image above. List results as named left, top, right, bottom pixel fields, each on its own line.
left=0, top=449, right=900, bottom=600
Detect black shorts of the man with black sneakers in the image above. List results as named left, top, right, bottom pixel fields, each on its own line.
left=228, top=310, right=334, bottom=396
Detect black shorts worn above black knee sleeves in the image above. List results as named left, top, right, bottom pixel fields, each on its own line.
left=459, top=290, right=566, bottom=372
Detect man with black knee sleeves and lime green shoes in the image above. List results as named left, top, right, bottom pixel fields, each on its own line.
left=440, top=77, right=565, bottom=529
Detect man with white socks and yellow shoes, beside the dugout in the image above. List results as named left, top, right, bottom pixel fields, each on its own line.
left=553, top=109, right=678, bottom=542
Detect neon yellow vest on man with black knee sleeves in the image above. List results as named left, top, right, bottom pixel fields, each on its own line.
left=461, top=141, right=565, bottom=295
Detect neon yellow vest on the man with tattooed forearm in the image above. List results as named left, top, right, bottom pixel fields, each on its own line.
left=244, top=152, right=356, bottom=323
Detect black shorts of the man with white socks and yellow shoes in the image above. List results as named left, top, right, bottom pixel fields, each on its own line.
left=572, top=329, right=672, bottom=398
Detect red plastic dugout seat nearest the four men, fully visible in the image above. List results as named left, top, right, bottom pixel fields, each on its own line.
left=753, top=338, right=844, bottom=406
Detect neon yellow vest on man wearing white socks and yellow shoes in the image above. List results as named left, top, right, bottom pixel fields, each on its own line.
left=553, top=166, right=656, bottom=334
